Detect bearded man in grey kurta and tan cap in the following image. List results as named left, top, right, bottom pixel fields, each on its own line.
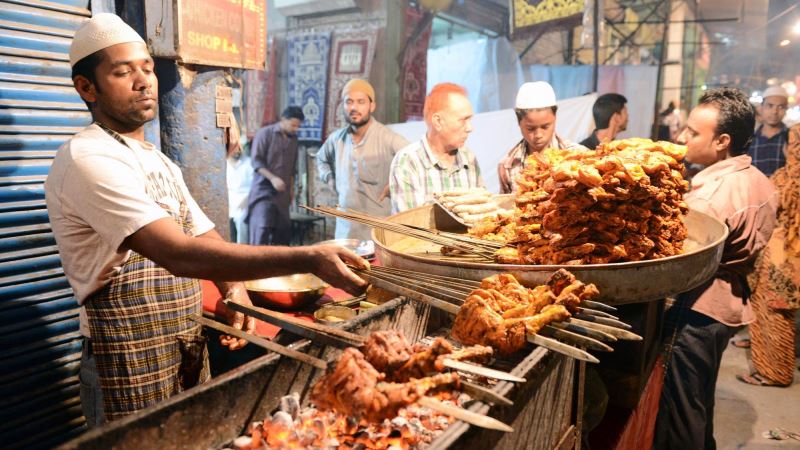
left=317, top=79, right=408, bottom=239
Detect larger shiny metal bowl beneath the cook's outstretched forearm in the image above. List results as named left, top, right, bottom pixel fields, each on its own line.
left=244, top=273, right=328, bottom=309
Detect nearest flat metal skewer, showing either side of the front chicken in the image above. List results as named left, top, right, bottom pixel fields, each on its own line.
left=189, top=315, right=514, bottom=433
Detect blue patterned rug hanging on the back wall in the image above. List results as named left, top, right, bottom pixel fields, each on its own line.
left=286, top=32, right=331, bottom=141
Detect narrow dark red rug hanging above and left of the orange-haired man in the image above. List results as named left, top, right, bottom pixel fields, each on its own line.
left=400, top=7, right=431, bottom=122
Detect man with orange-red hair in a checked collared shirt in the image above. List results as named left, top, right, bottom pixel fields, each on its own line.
left=389, top=83, right=484, bottom=213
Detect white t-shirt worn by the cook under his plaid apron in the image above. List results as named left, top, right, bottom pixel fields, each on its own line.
left=44, top=124, right=214, bottom=312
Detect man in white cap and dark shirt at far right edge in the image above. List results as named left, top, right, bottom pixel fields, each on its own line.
left=747, top=86, right=789, bottom=176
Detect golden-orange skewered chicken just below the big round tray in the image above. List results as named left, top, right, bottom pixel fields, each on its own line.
left=451, top=269, right=599, bottom=354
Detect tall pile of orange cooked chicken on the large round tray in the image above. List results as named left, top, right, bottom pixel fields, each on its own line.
left=470, top=139, right=688, bottom=264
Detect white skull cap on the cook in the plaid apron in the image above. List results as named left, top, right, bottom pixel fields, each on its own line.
left=69, top=13, right=146, bottom=67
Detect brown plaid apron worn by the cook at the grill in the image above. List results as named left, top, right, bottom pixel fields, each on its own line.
left=85, top=124, right=210, bottom=421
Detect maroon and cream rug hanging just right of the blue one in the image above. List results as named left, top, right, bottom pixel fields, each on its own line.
left=325, top=28, right=378, bottom=136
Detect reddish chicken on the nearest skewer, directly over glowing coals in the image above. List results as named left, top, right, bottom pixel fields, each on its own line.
left=311, top=347, right=459, bottom=422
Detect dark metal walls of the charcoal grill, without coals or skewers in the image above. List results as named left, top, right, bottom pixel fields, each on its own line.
left=60, top=298, right=584, bottom=450
